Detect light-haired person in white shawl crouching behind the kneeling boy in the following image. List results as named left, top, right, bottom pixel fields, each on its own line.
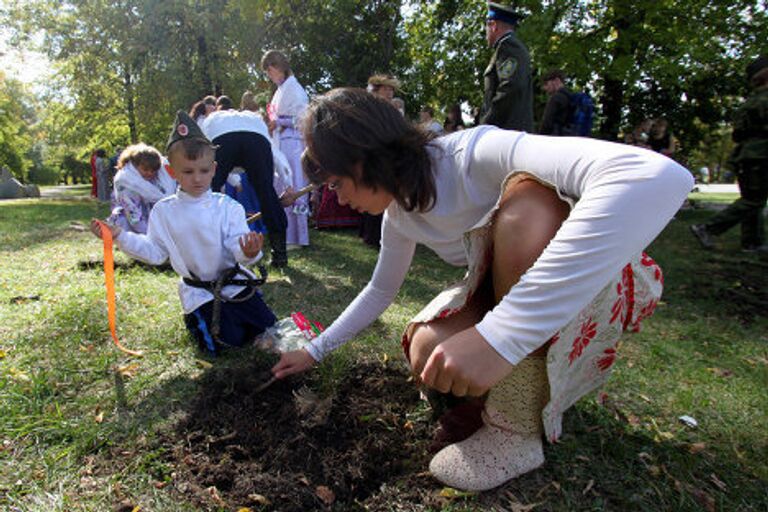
left=107, top=144, right=176, bottom=233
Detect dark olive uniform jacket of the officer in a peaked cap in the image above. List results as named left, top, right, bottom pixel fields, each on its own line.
left=480, top=32, right=533, bottom=132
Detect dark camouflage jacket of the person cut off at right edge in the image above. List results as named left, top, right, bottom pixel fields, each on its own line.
left=731, top=85, right=768, bottom=164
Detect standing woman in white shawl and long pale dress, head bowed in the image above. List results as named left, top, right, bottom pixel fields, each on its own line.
left=261, top=50, right=310, bottom=246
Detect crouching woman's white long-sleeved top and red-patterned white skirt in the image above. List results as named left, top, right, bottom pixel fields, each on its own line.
left=308, top=126, right=693, bottom=440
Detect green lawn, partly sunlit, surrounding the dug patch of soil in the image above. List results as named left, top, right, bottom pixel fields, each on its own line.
left=0, top=190, right=768, bottom=512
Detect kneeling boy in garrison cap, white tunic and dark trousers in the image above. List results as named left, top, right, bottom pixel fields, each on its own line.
left=91, top=111, right=276, bottom=353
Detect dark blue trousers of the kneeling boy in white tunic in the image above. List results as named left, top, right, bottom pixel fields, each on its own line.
left=184, top=289, right=277, bottom=353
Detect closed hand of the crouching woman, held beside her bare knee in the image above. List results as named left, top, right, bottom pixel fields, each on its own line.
left=420, top=327, right=513, bottom=396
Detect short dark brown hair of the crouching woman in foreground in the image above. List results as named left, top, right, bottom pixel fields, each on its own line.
left=302, top=88, right=437, bottom=212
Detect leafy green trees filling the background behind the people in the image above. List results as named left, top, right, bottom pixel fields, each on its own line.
left=0, top=0, right=768, bottom=184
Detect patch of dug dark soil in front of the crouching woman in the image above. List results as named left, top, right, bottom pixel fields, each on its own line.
left=163, top=364, right=436, bottom=511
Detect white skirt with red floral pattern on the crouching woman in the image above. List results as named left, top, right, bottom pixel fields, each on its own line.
left=402, top=180, right=663, bottom=442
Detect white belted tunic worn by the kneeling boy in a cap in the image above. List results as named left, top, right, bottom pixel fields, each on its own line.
left=115, top=189, right=261, bottom=314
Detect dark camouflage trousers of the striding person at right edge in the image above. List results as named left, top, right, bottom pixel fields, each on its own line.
left=706, top=159, right=768, bottom=249
